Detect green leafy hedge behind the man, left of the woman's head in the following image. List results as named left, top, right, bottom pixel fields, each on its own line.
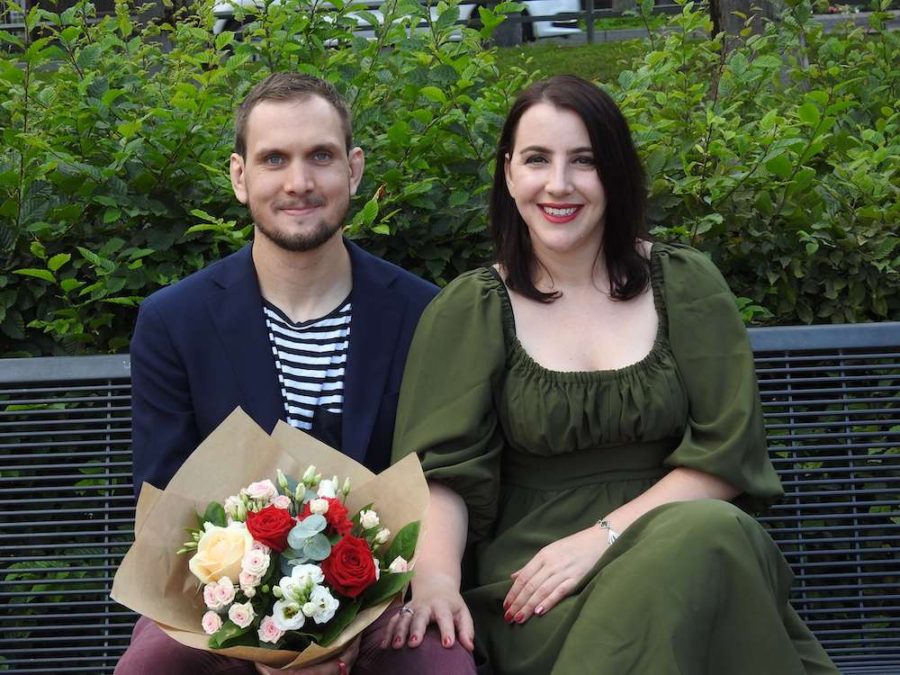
left=0, top=0, right=524, bottom=356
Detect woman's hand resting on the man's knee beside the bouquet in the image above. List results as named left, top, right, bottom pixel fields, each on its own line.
left=381, top=574, right=475, bottom=651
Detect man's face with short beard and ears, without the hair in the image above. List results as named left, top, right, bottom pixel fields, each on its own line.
left=231, top=96, right=364, bottom=251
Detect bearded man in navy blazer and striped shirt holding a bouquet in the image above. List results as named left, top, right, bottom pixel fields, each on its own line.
left=116, top=73, right=474, bottom=675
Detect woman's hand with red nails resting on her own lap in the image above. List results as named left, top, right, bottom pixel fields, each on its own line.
left=503, top=527, right=609, bottom=623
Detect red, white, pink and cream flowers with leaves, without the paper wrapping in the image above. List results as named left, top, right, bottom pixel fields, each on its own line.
left=184, top=466, right=419, bottom=651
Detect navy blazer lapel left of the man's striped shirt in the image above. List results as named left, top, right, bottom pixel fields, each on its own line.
left=207, top=244, right=284, bottom=433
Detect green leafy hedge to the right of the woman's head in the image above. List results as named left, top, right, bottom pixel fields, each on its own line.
left=614, top=0, right=900, bottom=324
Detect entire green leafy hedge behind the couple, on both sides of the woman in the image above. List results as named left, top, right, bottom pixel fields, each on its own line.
left=0, top=0, right=900, bottom=356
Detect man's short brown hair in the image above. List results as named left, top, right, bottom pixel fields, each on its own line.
left=234, top=72, right=353, bottom=158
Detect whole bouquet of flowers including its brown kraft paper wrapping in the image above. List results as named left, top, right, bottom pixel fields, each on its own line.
left=110, top=409, right=428, bottom=668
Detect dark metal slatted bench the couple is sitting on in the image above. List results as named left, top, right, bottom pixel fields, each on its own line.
left=0, top=323, right=900, bottom=675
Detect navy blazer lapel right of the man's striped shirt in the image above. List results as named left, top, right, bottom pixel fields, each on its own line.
left=341, top=242, right=405, bottom=462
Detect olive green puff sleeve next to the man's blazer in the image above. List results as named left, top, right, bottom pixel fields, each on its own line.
left=393, top=269, right=506, bottom=543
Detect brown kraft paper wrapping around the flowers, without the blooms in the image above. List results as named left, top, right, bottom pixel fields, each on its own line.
left=110, top=408, right=428, bottom=668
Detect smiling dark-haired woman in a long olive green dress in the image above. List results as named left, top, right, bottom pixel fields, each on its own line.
left=390, top=77, right=836, bottom=675
